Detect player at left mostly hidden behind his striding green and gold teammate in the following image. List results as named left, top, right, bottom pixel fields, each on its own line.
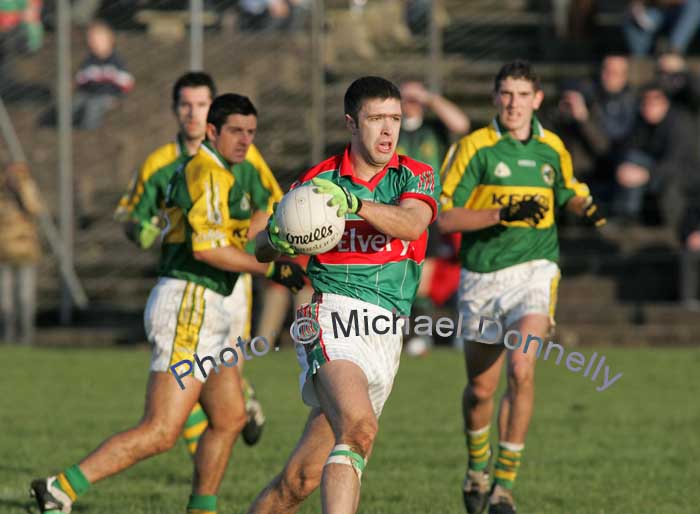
left=115, top=72, right=282, bottom=448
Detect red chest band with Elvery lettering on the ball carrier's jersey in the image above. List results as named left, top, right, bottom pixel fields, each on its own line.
left=317, top=220, right=427, bottom=264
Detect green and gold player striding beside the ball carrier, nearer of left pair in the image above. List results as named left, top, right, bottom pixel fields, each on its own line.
left=32, top=94, right=304, bottom=514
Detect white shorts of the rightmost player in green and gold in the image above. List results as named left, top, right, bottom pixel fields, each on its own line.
left=458, top=259, right=560, bottom=342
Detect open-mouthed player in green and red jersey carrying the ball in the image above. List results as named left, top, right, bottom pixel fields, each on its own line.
left=249, top=77, right=440, bottom=514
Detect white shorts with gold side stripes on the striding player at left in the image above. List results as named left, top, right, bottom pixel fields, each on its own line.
left=144, top=277, right=231, bottom=382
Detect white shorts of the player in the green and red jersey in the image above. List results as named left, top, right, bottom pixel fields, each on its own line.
left=295, top=293, right=403, bottom=417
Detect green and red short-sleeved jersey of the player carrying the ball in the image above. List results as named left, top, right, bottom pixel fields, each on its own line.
left=292, top=143, right=440, bottom=315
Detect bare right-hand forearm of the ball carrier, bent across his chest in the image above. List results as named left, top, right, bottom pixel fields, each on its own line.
left=357, top=198, right=433, bottom=241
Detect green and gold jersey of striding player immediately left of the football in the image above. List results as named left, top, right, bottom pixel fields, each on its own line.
left=160, top=142, right=281, bottom=296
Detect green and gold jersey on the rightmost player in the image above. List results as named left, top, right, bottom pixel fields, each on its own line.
left=440, top=117, right=589, bottom=273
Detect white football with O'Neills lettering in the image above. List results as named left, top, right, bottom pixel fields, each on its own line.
left=275, top=184, right=345, bottom=255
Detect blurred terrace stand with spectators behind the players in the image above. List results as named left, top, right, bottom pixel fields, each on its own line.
left=0, top=0, right=700, bottom=353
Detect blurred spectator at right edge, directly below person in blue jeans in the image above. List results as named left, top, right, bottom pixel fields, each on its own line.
left=656, top=52, right=700, bottom=114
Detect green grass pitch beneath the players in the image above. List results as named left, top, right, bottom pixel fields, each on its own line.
left=0, top=347, right=700, bottom=514
